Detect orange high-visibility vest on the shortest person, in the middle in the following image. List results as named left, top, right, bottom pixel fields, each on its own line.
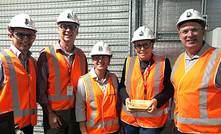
left=82, top=73, right=119, bottom=134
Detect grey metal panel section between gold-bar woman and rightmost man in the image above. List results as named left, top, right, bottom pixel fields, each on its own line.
left=142, top=0, right=202, bottom=66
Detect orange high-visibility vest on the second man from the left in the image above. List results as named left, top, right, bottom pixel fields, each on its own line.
left=45, top=45, right=86, bottom=110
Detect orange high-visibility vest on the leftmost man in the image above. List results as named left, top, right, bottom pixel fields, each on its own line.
left=0, top=50, right=37, bottom=128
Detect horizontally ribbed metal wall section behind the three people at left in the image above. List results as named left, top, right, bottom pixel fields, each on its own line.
left=0, top=0, right=131, bottom=134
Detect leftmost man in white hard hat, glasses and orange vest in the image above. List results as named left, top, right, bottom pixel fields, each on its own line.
left=0, top=14, right=37, bottom=134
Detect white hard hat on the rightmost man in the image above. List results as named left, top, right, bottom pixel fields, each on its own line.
left=176, top=9, right=206, bottom=30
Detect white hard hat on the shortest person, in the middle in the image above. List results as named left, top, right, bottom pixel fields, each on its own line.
left=90, top=42, right=113, bottom=56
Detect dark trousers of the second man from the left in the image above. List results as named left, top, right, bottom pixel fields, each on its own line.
left=43, top=108, right=81, bottom=134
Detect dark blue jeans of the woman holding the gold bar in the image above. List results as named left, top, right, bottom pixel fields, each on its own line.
left=125, top=124, right=164, bottom=134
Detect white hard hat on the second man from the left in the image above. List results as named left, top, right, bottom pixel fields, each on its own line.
left=57, top=9, right=80, bottom=25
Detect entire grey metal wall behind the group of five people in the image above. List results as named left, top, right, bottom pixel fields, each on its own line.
left=0, top=0, right=221, bottom=134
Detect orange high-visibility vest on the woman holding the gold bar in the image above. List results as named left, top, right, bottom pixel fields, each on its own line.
left=121, top=56, right=169, bottom=128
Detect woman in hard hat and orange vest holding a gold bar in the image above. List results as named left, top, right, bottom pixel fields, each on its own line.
left=119, top=26, right=174, bottom=134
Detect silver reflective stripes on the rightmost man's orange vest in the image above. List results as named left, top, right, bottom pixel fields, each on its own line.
left=174, top=48, right=221, bottom=126
